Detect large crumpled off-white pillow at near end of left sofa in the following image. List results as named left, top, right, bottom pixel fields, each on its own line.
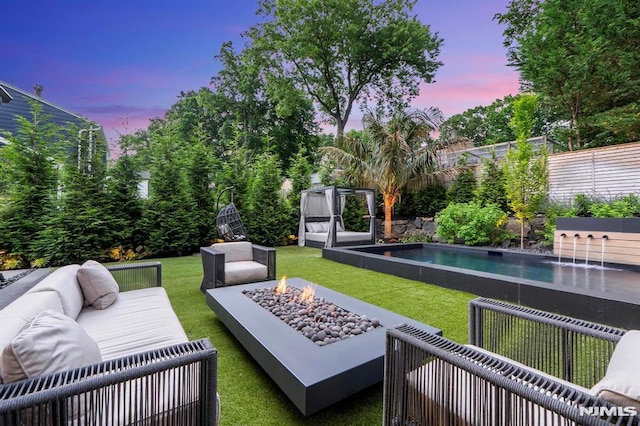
left=0, top=309, right=102, bottom=383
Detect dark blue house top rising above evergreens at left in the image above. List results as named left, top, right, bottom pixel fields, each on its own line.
left=0, top=81, right=104, bottom=143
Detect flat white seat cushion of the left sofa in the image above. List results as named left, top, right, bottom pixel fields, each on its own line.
left=78, top=287, right=188, bottom=360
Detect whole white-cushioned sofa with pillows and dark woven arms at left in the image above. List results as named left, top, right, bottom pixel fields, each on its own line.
left=0, top=261, right=219, bottom=426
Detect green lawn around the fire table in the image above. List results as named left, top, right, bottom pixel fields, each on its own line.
left=160, top=246, right=474, bottom=426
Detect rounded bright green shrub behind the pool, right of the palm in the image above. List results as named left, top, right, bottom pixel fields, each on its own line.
left=436, top=201, right=508, bottom=246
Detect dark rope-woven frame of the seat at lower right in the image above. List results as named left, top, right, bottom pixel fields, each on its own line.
left=383, top=298, right=640, bottom=426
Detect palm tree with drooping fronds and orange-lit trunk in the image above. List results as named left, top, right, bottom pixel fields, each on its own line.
left=320, top=108, right=443, bottom=239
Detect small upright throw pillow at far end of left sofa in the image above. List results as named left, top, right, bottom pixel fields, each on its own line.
left=78, top=260, right=120, bottom=309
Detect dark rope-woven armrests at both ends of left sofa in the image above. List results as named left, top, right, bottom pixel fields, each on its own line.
left=0, top=263, right=219, bottom=426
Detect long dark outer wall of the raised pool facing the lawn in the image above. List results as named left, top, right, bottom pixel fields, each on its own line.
left=322, top=244, right=640, bottom=329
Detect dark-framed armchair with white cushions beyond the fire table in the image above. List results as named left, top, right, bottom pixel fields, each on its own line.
left=200, top=241, right=276, bottom=293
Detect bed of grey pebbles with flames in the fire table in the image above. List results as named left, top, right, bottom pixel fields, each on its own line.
left=242, top=281, right=381, bottom=346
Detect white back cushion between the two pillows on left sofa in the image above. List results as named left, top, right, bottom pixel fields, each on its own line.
left=29, top=265, right=84, bottom=319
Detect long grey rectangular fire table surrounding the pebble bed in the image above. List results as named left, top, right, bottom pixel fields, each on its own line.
left=206, top=278, right=441, bottom=416
